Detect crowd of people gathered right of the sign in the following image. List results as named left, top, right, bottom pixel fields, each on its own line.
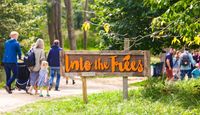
left=165, top=48, right=200, bottom=81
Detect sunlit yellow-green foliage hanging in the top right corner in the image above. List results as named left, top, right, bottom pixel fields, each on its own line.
left=145, top=0, right=200, bottom=48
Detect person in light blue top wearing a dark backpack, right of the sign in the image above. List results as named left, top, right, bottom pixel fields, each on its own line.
left=179, top=48, right=196, bottom=80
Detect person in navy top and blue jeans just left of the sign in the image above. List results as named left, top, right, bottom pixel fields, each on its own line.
left=47, top=40, right=62, bottom=91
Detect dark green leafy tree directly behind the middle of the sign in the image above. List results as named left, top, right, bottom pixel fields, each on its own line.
left=91, top=0, right=162, bottom=52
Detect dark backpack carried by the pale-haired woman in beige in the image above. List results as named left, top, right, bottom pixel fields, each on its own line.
left=24, top=50, right=35, bottom=67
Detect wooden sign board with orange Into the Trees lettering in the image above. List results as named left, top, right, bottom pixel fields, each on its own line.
left=64, top=50, right=150, bottom=76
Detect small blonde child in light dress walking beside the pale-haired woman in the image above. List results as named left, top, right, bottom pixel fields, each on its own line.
left=38, top=61, right=50, bottom=97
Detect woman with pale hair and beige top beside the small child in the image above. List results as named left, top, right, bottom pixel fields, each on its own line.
left=28, top=39, right=45, bottom=95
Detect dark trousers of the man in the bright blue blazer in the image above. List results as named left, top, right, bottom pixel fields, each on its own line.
left=4, top=63, right=18, bottom=88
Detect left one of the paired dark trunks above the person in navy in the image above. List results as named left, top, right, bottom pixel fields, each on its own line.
left=47, top=0, right=55, bottom=45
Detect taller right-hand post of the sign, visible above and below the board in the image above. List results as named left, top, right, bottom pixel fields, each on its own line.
left=123, top=38, right=130, bottom=100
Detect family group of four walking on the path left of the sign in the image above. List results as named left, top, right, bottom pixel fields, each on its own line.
left=2, top=31, right=69, bottom=97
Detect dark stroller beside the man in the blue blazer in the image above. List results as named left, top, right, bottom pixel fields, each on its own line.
left=16, top=63, right=30, bottom=93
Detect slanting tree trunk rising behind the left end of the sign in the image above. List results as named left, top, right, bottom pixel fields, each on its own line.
left=64, top=0, right=76, bottom=50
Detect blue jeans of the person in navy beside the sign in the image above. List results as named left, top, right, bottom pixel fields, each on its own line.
left=50, top=68, right=60, bottom=89
